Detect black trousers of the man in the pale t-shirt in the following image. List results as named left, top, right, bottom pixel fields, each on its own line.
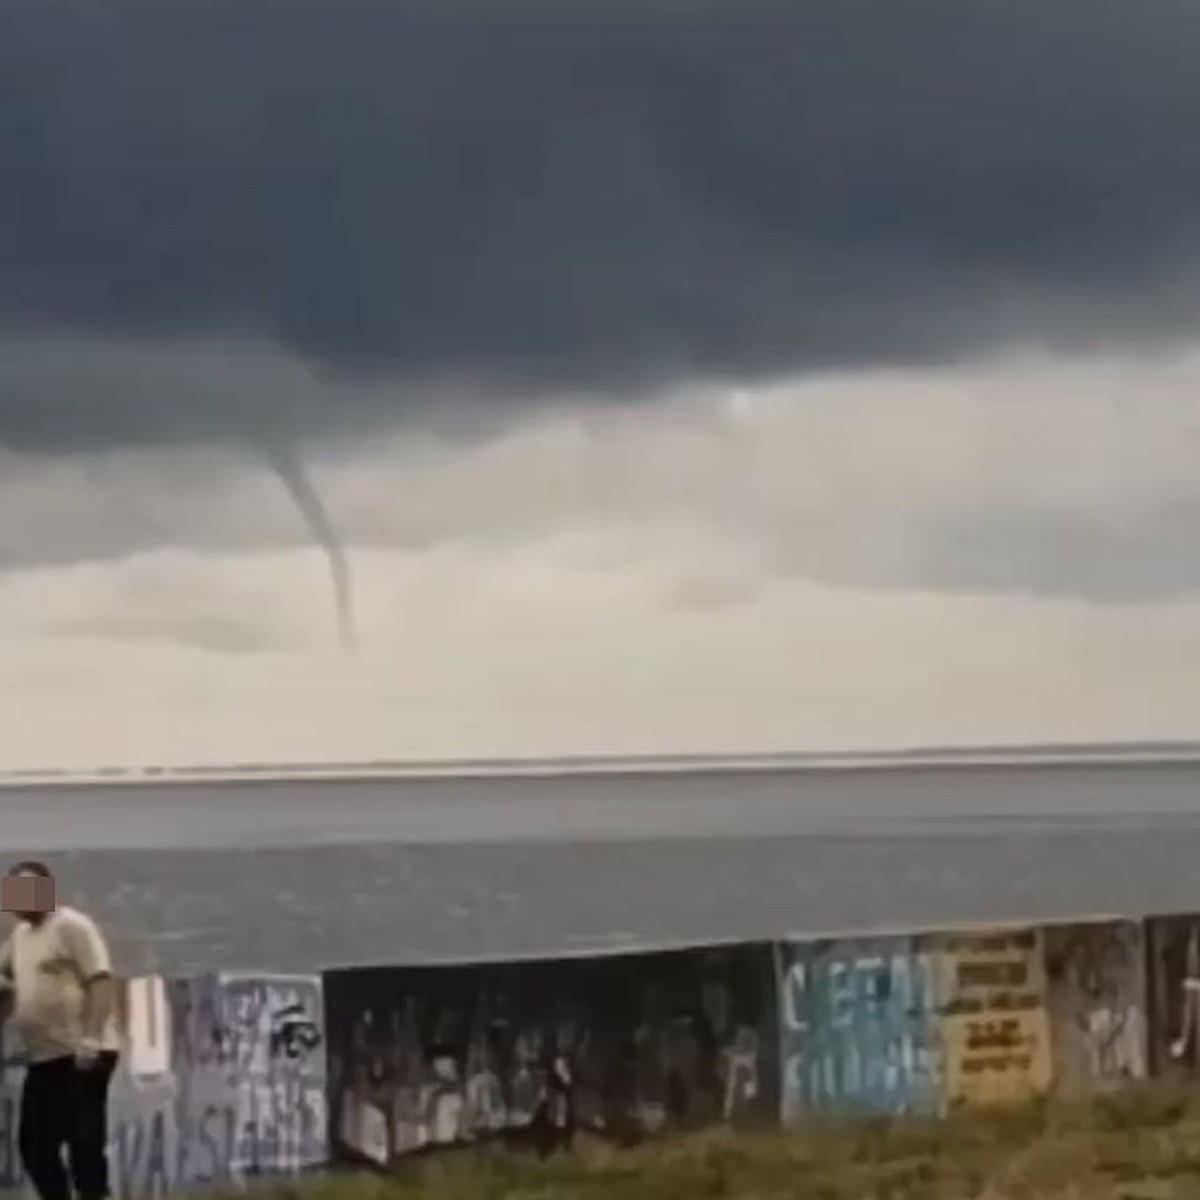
left=17, top=1050, right=116, bottom=1200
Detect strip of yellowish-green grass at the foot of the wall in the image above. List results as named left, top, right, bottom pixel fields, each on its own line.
left=220, top=1086, right=1200, bottom=1200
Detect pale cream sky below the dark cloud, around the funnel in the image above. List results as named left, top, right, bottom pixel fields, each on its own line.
left=7, top=350, right=1200, bottom=768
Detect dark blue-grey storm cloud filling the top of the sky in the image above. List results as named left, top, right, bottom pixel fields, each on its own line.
left=0, top=0, right=1200, bottom=448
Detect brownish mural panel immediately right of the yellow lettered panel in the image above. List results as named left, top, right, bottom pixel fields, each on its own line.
left=1043, top=920, right=1147, bottom=1099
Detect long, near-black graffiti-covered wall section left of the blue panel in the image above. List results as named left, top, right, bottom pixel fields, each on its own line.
left=325, top=946, right=778, bottom=1163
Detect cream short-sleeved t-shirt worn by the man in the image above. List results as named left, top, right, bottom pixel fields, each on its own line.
left=0, top=905, right=119, bottom=1062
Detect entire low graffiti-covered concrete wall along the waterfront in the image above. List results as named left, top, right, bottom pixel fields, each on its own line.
left=7, top=914, right=1200, bottom=1200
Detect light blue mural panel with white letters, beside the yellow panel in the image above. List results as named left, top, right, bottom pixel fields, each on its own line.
left=779, top=936, right=942, bottom=1122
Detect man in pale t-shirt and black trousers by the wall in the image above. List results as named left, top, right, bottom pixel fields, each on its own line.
left=0, top=860, right=119, bottom=1200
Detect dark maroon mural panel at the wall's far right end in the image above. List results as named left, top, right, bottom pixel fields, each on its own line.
left=1145, top=913, right=1200, bottom=1075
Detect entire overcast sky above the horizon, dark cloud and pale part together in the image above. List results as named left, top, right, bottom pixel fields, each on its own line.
left=0, top=0, right=1200, bottom=766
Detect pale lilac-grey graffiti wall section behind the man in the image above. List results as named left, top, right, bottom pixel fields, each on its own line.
left=0, top=973, right=329, bottom=1200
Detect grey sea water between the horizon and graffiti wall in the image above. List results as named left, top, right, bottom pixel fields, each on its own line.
left=7, top=763, right=1200, bottom=973
